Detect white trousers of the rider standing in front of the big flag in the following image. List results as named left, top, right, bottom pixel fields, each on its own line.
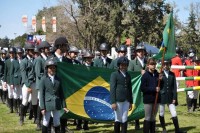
left=114, top=101, right=130, bottom=123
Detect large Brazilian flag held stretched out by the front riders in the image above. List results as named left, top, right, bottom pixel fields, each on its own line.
left=57, top=62, right=144, bottom=122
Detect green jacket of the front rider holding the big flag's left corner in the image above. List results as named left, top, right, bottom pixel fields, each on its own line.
left=39, top=75, right=66, bottom=111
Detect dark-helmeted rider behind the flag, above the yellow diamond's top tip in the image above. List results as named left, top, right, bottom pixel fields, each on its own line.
left=94, top=43, right=112, bottom=68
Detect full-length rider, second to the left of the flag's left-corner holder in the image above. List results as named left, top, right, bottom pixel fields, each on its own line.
left=20, top=42, right=38, bottom=126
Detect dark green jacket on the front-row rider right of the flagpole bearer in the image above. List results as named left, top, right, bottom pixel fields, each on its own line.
left=160, top=71, right=177, bottom=104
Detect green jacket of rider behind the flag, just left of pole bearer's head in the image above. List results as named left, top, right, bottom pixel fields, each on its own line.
left=128, top=57, right=146, bottom=71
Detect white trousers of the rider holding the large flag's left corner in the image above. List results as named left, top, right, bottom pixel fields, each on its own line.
left=43, top=110, right=60, bottom=127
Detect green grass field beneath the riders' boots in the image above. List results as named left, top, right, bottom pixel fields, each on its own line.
left=0, top=83, right=200, bottom=133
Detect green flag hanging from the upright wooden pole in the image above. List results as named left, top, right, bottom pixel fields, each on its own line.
left=153, top=12, right=176, bottom=59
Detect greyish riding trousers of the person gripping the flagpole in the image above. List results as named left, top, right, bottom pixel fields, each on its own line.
left=144, top=103, right=159, bottom=121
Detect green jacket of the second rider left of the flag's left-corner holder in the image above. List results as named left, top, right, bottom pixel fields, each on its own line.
left=20, top=57, right=35, bottom=87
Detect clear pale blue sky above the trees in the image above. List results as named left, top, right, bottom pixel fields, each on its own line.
left=0, top=0, right=199, bottom=39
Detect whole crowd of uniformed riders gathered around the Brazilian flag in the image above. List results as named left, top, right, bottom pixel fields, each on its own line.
left=0, top=37, right=200, bottom=133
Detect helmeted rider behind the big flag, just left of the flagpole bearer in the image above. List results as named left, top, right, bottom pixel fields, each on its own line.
left=128, top=43, right=147, bottom=130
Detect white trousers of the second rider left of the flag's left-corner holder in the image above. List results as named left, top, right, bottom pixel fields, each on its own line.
left=22, top=83, right=38, bottom=106
